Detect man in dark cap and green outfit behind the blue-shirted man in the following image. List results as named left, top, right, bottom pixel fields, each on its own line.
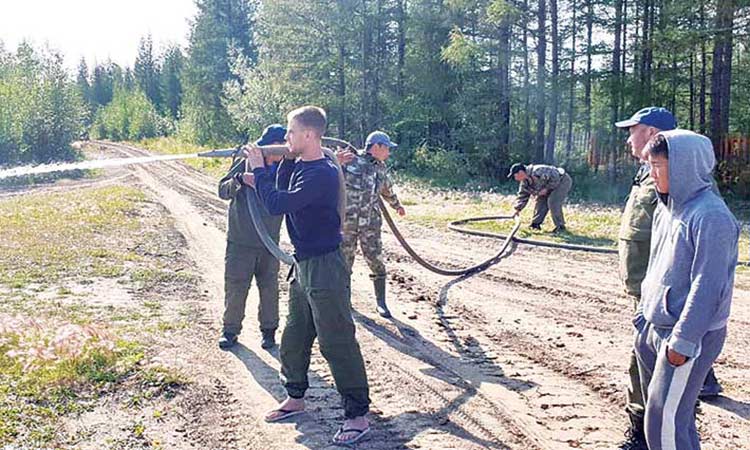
left=219, top=124, right=286, bottom=350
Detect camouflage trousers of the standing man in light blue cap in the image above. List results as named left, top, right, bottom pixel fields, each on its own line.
left=341, top=214, right=385, bottom=280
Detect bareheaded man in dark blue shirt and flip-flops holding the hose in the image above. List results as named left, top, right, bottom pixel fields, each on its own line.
left=247, top=106, right=370, bottom=444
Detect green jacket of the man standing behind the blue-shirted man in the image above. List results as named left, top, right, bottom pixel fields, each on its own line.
left=219, top=159, right=284, bottom=248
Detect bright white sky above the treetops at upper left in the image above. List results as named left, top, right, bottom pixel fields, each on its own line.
left=0, top=0, right=197, bottom=69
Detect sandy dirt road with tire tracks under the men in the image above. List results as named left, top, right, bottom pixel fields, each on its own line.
left=85, top=145, right=750, bottom=450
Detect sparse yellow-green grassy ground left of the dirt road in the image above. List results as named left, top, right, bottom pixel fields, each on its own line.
left=0, top=177, right=195, bottom=448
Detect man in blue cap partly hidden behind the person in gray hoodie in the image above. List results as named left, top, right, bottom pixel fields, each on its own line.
left=615, top=106, right=721, bottom=450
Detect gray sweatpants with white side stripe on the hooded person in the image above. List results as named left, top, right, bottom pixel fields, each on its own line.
left=635, top=322, right=727, bottom=450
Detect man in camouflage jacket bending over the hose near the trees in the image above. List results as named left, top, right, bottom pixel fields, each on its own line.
left=508, top=164, right=573, bottom=233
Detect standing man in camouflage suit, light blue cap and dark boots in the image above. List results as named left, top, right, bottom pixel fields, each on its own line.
left=342, top=131, right=406, bottom=318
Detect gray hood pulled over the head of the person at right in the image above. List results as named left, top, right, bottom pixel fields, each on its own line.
left=659, top=129, right=716, bottom=208
